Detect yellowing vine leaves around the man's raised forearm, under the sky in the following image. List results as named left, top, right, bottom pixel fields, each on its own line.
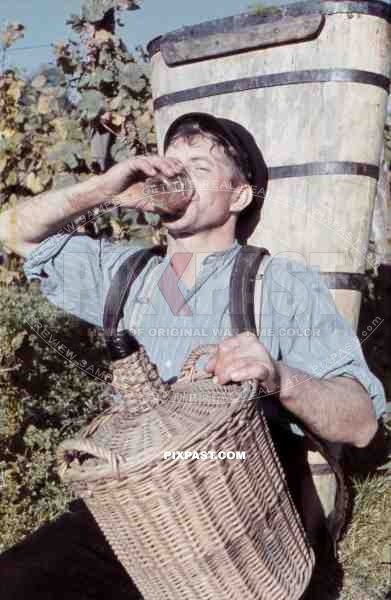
left=0, top=0, right=164, bottom=270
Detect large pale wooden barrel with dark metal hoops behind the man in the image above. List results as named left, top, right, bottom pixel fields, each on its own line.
left=148, top=0, right=391, bottom=330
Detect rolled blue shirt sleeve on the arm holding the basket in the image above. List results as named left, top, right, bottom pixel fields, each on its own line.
left=265, top=257, right=386, bottom=417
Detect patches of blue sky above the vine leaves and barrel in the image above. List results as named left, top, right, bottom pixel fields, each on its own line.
left=0, top=0, right=297, bottom=72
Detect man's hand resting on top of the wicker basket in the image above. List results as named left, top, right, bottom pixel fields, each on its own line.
left=206, top=331, right=279, bottom=393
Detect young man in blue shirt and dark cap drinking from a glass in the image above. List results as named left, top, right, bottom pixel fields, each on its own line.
left=0, top=113, right=385, bottom=600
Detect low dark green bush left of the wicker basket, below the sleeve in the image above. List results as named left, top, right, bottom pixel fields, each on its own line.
left=0, top=286, right=111, bottom=551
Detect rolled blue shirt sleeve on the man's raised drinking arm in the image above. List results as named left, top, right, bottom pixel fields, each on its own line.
left=23, top=231, right=141, bottom=327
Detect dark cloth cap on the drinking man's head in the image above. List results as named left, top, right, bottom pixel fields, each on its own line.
left=163, top=112, right=268, bottom=199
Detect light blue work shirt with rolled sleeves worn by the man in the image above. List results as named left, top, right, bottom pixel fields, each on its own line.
left=24, top=231, right=386, bottom=433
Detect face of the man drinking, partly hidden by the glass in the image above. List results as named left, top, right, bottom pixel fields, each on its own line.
left=165, top=135, right=236, bottom=235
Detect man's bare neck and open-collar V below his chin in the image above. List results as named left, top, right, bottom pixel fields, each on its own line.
left=167, top=234, right=234, bottom=287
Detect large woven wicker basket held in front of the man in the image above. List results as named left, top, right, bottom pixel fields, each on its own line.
left=58, top=345, right=314, bottom=600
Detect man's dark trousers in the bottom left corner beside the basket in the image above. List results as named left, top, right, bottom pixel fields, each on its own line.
left=0, top=500, right=142, bottom=600
